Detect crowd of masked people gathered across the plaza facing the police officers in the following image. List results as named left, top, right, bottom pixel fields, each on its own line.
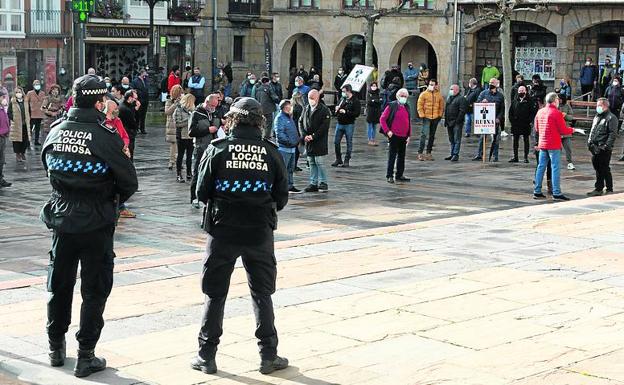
left=0, top=58, right=624, bottom=200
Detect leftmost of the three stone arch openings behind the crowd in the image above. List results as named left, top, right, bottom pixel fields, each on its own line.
left=279, top=32, right=323, bottom=87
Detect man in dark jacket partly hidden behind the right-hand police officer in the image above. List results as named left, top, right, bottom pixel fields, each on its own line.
left=188, top=94, right=221, bottom=209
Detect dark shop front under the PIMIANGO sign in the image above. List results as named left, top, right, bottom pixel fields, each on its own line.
left=85, top=24, right=149, bottom=83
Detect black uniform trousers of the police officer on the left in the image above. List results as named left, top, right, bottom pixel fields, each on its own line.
left=47, top=226, right=115, bottom=350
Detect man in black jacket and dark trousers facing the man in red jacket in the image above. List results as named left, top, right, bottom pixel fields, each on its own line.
left=587, top=98, right=618, bottom=196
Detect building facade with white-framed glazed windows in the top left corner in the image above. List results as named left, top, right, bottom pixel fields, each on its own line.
left=0, top=0, right=71, bottom=94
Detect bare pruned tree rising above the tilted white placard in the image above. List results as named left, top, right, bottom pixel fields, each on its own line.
left=334, top=0, right=408, bottom=67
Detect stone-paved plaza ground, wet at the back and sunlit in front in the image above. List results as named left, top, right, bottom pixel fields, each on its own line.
left=0, top=115, right=624, bottom=385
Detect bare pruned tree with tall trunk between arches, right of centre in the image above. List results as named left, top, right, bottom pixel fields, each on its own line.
left=465, top=0, right=547, bottom=127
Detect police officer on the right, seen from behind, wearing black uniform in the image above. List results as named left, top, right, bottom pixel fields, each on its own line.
left=191, top=97, right=288, bottom=374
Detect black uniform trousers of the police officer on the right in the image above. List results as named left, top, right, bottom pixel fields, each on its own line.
left=198, top=231, right=278, bottom=360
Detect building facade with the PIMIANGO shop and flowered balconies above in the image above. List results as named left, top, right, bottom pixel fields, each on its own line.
left=84, top=0, right=203, bottom=82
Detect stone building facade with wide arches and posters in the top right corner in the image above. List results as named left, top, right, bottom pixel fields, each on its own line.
left=459, top=0, right=624, bottom=95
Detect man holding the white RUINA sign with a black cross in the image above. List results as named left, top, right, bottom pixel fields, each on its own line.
left=472, top=78, right=505, bottom=162
